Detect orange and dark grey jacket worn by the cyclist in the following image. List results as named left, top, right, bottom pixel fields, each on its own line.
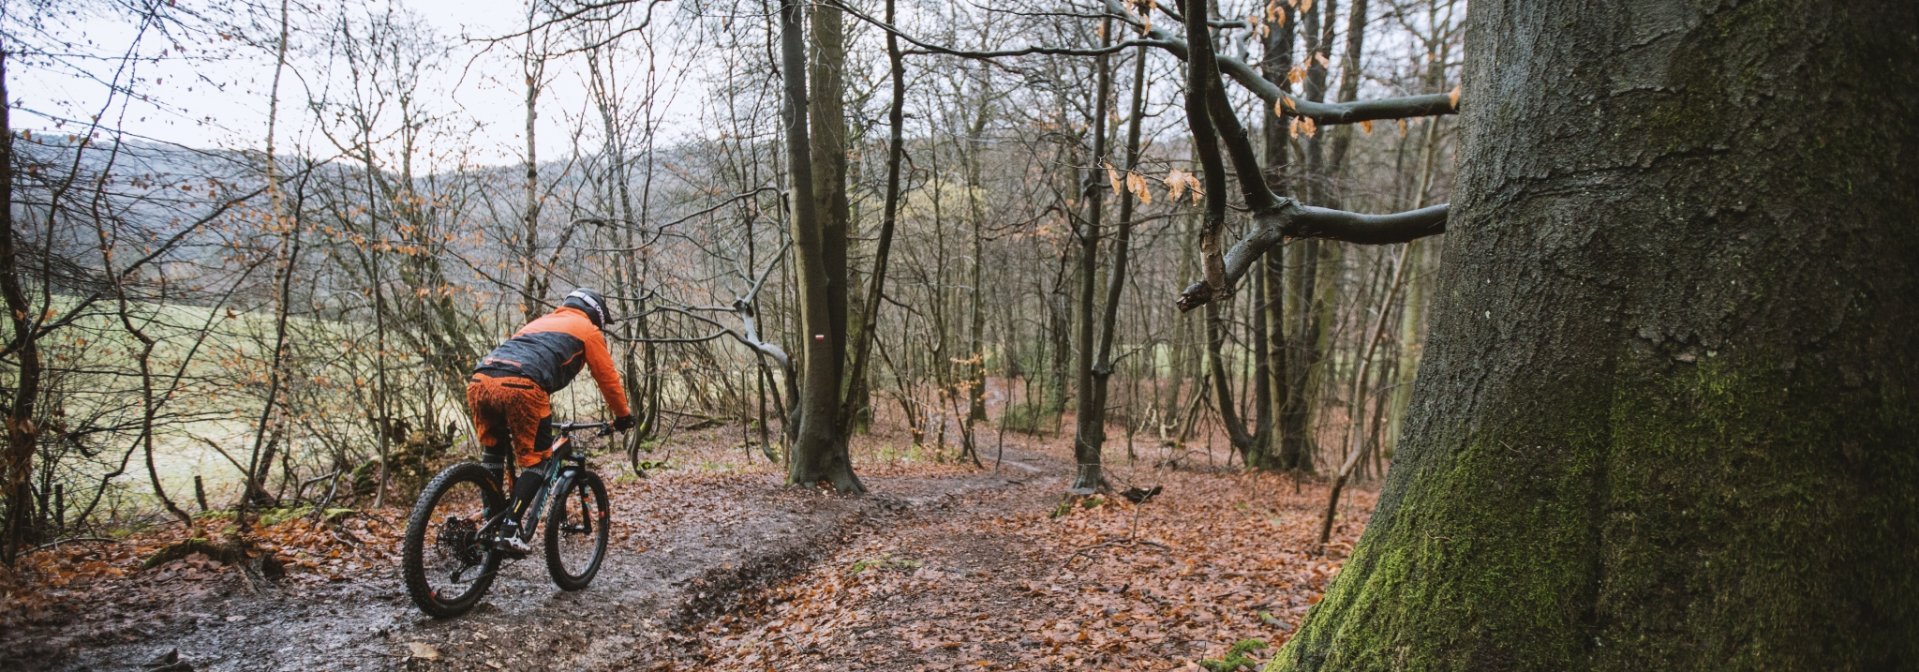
left=474, top=307, right=631, bottom=419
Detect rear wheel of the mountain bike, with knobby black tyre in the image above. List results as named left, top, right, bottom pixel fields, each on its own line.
left=401, top=463, right=507, bottom=618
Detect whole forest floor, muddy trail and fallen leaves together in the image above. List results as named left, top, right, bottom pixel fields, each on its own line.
left=0, top=416, right=1374, bottom=670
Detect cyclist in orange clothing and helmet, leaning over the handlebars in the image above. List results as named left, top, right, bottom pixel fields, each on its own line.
left=466, top=288, right=633, bottom=553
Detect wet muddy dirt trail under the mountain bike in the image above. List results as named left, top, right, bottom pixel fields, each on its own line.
left=0, top=451, right=1059, bottom=670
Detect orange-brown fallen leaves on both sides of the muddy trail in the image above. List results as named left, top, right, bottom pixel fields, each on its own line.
left=0, top=416, right=1372, bottom=670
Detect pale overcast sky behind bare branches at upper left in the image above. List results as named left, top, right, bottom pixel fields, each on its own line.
left=6, top=0, right=700, bottom=167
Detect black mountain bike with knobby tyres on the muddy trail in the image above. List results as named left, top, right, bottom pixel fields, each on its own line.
left=401, top=422, right=612, bottom=618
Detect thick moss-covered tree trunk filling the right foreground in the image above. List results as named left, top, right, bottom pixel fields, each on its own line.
left=1268, top=0, right=1919, bottom=670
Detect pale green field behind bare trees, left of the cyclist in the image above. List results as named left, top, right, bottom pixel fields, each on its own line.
left=4, top=296, right=464, bottom=511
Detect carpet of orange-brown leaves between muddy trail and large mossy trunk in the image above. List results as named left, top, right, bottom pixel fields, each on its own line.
left=699, top=435, right=1372, bottom=670
